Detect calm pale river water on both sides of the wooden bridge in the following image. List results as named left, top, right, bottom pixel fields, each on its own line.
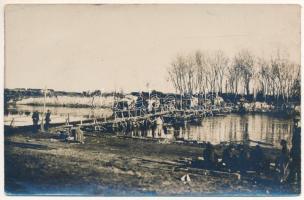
left=4, top=106, right=293, bottom=148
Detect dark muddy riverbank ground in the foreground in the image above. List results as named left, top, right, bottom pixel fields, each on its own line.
left=5, top=132, right=299, bottom=196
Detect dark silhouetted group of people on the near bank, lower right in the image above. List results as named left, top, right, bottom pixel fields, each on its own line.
left=203, top=117, right=301, bottom=183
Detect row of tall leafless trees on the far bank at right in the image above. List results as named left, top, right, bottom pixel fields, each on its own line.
left=168, top=50, right=301, bottom=102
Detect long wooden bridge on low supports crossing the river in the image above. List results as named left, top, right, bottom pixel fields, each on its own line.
left=5, top=103, right=228, bottom=132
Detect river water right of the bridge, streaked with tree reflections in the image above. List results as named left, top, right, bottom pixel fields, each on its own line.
left=118, top=114, right=293, bottom=148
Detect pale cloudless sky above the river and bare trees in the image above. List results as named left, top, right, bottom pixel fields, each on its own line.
left=5, top=5, right=300, bottom=92
